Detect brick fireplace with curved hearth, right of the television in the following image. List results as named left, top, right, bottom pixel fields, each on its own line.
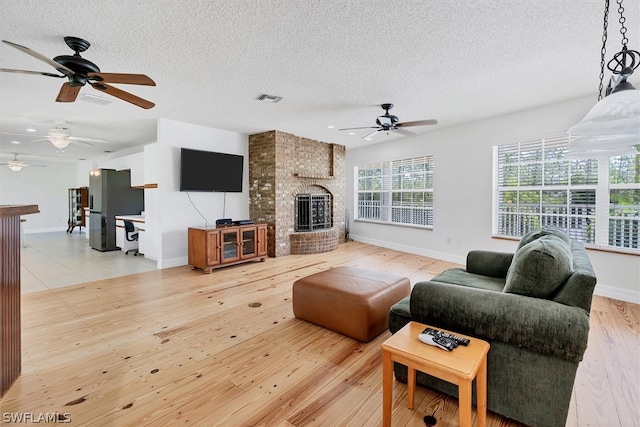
left=249, top=130, right=346, bottom=257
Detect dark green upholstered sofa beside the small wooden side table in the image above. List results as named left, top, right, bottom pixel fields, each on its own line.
left=389, top=227, right=596, bottom=427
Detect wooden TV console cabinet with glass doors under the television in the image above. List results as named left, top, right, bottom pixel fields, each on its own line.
left=188, top=224, right=267, bottom=273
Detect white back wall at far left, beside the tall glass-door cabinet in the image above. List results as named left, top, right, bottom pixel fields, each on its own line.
left=0, top=157, right=76, bottom=233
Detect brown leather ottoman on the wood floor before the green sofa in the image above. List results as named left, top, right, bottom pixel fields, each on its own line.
left=293, top=267, right=411, bottom=342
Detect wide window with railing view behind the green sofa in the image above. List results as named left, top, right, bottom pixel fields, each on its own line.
left=494, top=136, right=640, bottom=250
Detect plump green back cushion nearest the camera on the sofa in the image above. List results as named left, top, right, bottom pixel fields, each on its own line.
left=504, top=235, right=572, bottom=298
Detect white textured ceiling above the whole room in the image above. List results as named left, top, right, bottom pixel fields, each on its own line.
left=0, top=0, right=640, bottom=165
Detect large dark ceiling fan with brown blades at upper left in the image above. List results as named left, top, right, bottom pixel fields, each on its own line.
left=0, top=37, right=156, bottom=109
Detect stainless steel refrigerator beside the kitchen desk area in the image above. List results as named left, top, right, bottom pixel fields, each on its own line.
left=89, top=169, right=144, bottom=252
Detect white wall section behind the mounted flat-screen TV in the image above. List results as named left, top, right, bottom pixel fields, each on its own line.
left=157, top=119, right=249, bottom=268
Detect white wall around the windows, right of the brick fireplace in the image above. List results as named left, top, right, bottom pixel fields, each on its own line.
left=346, top=97, right=640, bottom=303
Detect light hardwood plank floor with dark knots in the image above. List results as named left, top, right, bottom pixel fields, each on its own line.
left=0, top=242, right=640, bottom=427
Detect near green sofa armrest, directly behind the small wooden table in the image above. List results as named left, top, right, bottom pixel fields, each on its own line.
left=410, top=281, right=589, bottom=362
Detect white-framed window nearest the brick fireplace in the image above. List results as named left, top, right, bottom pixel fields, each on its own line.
left=355, top=156, right=433, bottom=227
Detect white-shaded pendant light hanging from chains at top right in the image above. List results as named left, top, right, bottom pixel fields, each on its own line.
left=567, top=0, right=640, bottom=154
